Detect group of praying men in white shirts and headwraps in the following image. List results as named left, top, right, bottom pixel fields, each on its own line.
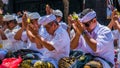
left=0, top=8, right=120, bottom=68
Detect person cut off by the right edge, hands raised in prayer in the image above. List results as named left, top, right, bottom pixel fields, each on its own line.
left=108, top=10, right=120, bottom=68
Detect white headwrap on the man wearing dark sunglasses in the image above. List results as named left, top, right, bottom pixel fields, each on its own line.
left=80, top=11, right=96, bottom=23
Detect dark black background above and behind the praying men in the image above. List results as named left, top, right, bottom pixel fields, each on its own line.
left=5, top=0, right=119, bottom=25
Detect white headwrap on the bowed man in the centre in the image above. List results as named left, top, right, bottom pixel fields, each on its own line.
left=38, top=14, right=56, bottom=25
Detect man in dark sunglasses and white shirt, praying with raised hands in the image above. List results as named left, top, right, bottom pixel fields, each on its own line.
left=71, top=9, right=114, bottom=68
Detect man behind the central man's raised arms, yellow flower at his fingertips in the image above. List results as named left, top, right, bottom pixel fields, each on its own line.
left=14, top=12, right=43, bottom=57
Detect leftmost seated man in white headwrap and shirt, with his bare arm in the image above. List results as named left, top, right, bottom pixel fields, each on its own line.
left=0, top=15, right=23, bottom=60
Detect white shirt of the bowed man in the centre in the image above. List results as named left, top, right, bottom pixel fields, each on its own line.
left=40, top=27, right=70, bottom=61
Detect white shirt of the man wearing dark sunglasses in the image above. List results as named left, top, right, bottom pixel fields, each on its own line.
left=77, top=24, right=114, bottom=64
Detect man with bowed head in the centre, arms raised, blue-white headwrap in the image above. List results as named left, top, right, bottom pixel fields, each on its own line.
left=28, top=14, right=70, bottom=68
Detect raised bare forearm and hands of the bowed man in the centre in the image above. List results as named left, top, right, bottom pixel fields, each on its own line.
left=27, top=24, right=55, bottom=51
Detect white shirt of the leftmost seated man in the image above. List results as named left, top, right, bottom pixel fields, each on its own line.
left=3, top=26, right=24, bottom=51
